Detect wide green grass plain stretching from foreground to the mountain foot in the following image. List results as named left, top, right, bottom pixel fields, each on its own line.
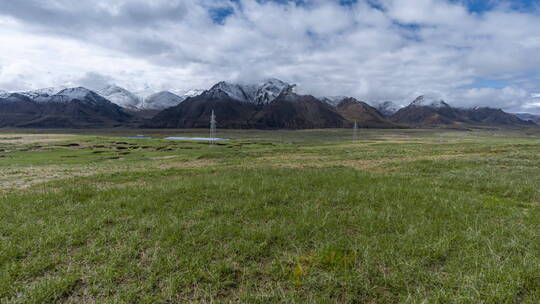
left=0, top=130, right=540, bottom=303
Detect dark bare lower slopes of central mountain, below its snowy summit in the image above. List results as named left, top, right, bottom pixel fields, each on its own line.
left=148, top=89, right=352, bottom=129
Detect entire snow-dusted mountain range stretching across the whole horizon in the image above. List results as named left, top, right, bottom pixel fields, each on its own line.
left=0, top=79, right=539, bottom=129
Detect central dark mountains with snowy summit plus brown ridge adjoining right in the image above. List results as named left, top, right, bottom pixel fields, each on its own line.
left=146, top=79, right=402, bottom=129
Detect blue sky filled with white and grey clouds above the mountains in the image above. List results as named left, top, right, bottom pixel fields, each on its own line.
left=0, top=0, right=540, bottom=113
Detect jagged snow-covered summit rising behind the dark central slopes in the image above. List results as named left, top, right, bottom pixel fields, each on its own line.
left=209, top=78, right=295, bottom=105
